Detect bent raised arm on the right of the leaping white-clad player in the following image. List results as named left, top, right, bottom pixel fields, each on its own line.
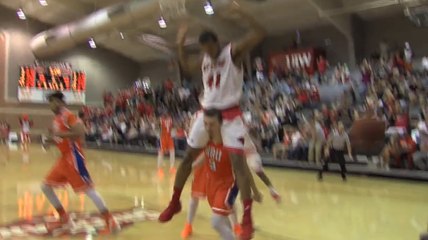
left=231, top=2, right=266, bottom=65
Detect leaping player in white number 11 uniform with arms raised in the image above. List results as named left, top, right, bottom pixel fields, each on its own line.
left=159, top=3, right=265, bottom=239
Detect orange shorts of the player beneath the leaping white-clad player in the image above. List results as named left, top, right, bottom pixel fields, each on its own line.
left=207, top=178, right=238, bottom=216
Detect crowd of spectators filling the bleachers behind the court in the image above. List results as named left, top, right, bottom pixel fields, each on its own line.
left=82, top=41, right=428, bottom=170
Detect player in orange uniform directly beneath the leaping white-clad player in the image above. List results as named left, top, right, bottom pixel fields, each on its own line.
left=189, top=110, right=239, bottom=240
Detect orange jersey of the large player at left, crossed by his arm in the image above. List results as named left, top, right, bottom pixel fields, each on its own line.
left=53, top=108, right=82, bottom=155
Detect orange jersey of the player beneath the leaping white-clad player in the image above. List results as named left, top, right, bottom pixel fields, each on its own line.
left=204, top=142, right=234, bottom=181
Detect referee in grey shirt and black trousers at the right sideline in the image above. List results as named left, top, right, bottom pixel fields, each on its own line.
left=318, top=122, right=352, bottom=181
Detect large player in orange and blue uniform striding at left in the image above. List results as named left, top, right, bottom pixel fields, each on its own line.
left=42, top=92, right=120, bottom=232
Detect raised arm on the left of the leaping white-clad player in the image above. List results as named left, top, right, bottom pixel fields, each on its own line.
left=177, top=23, right=201, bottom=75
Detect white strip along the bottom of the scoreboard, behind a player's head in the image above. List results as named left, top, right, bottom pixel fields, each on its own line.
left=18, top=87, right=86, bottom=105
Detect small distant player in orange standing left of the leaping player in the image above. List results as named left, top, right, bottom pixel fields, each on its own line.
left=158, top=113, right=176, bottom=176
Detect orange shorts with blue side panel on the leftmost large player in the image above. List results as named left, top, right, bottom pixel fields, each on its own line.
left=45, top=153, right=93, bottom=192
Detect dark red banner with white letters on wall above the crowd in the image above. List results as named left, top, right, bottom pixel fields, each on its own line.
left=269, top=48, right=323, bottom=74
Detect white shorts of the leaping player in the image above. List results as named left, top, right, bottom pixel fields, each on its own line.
left=187, top=111, right=247, bottom=153
